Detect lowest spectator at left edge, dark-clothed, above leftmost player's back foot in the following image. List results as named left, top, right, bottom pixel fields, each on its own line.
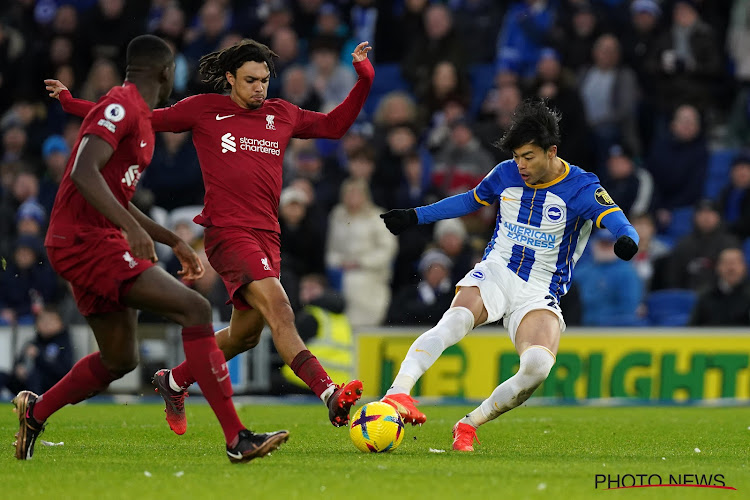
left=0, top=306, right=74, bottom=394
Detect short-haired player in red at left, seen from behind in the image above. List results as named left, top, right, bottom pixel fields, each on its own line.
left=13, top=35, right=289, bottom=462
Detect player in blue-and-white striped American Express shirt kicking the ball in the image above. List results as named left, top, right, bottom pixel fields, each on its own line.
left=381, top=100, right=638, bottom=451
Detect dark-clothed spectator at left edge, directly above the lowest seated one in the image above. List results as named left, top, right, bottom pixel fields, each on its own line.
left=0, top=235, right=57, bottom=325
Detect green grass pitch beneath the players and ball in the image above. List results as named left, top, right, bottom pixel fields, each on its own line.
left=0, top=398, right=750, bottom=500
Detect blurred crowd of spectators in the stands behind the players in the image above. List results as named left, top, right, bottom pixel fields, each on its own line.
left=0, top=0, right=750, bottom=344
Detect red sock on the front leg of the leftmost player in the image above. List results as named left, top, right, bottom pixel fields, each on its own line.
left=182, top=324, right=245, bottom=443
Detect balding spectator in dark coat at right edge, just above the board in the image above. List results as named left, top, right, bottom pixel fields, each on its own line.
left=690, top=247, right=750, bottom=326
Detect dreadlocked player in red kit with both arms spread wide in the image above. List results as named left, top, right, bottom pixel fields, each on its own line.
left=45, top=40, right=374, bottom=434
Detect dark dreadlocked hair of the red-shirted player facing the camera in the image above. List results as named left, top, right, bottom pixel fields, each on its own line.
left=198, top=38, right=279, bottom=90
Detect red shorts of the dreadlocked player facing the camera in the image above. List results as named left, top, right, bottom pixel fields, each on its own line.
left=204, top=226, right=281, bottom=310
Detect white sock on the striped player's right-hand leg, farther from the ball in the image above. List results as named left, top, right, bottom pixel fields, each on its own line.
left=460, top=345, right=555, bottom=427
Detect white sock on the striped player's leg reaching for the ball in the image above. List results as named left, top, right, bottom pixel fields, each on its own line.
left=386, top=307, right=474, bottom=395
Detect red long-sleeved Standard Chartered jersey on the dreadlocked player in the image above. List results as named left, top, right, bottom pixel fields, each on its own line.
left=55, top=59, right=375, bottom=232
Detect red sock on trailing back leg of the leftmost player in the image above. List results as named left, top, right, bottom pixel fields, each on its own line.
left=33, top=351, right=120, bottom=422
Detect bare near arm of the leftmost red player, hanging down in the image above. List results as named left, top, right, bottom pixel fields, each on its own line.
left=70, top=134, right=156, bottom=262
